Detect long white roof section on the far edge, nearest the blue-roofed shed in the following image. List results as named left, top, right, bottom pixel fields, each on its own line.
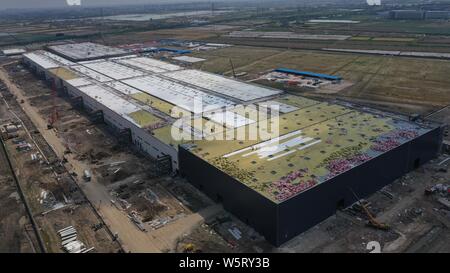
left=164, top=70, right=282, bottom=101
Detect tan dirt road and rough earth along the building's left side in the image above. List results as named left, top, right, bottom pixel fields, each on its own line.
left=0, top=61, right=225, bottom=252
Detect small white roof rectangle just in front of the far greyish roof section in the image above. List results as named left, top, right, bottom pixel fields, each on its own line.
left=83, top=61, right=144, bottom=80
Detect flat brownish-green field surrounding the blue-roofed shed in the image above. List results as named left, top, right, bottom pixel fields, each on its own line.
left=193, top=45, right=450, bottom=114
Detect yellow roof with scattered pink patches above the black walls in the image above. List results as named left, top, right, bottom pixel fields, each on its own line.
left=184, top=96, right=436, bottom=203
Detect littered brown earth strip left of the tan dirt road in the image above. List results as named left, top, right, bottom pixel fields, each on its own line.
left=0, top=79, right=120, bottom=252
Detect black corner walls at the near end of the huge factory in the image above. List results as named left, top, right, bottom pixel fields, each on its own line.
left=179, top=126, right=443, bottom=246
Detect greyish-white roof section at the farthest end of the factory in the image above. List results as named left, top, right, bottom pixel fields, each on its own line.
left=49, top=42, right=127, bottom=60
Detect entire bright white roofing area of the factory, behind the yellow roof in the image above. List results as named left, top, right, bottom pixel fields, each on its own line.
left=24, top=45, right=288, bottom=125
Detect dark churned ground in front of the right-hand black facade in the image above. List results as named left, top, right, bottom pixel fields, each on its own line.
left=279, top=155, right=450, bottom=253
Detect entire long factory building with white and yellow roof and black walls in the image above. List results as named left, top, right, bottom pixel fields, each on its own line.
left=24, top=43, right=442, bottom=246
